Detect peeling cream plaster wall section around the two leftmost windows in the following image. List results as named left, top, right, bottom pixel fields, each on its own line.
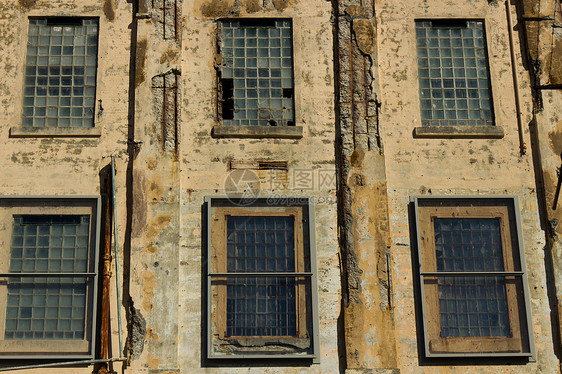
left=0, top=0, right=131, bottom=374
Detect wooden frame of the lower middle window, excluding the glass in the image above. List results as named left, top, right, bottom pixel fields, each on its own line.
left=205, top=196, right=319, bottom=362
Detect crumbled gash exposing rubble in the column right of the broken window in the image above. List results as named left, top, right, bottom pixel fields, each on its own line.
left=336, top=2, right=382, bottom=303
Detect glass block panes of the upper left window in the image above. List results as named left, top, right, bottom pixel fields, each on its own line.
left=22, top=17, right=98, bottom=128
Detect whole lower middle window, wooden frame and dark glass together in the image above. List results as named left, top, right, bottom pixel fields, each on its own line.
left=207, top=198, right=318, bottom=358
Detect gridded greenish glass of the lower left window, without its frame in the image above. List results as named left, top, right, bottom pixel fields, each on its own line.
left=5, top=215, right=90, bottom=339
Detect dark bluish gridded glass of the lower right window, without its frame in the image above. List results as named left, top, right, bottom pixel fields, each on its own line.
left=434, top=218, right=510, bottom=337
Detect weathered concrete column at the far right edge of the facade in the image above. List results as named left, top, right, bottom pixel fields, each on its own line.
left=516, top=0, right=562, bottom=357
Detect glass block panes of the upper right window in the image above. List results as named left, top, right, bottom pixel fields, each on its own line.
left=416, top=20, right=493, bottom=126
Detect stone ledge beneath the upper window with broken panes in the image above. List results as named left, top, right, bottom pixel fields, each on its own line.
left=212, top=125, right=303, bottom=139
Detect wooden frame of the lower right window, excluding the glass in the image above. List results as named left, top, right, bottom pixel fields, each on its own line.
left=416, top=197, right=534, bottom=357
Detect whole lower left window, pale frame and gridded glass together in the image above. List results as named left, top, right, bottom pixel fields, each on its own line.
left=0, top=198, right=99, bottom=358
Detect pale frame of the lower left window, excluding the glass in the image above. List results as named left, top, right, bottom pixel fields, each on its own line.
left=0, top=196, right=101, bottom=360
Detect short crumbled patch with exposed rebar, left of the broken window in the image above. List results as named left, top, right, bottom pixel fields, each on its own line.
left=152, top=69, right=181, bottom=158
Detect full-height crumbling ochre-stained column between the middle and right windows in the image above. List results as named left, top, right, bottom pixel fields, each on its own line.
left=334, top=0, right=397, bottom=372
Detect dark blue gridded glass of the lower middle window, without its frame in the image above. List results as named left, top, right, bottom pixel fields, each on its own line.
left=226, top=216, right=297, bottom=336
